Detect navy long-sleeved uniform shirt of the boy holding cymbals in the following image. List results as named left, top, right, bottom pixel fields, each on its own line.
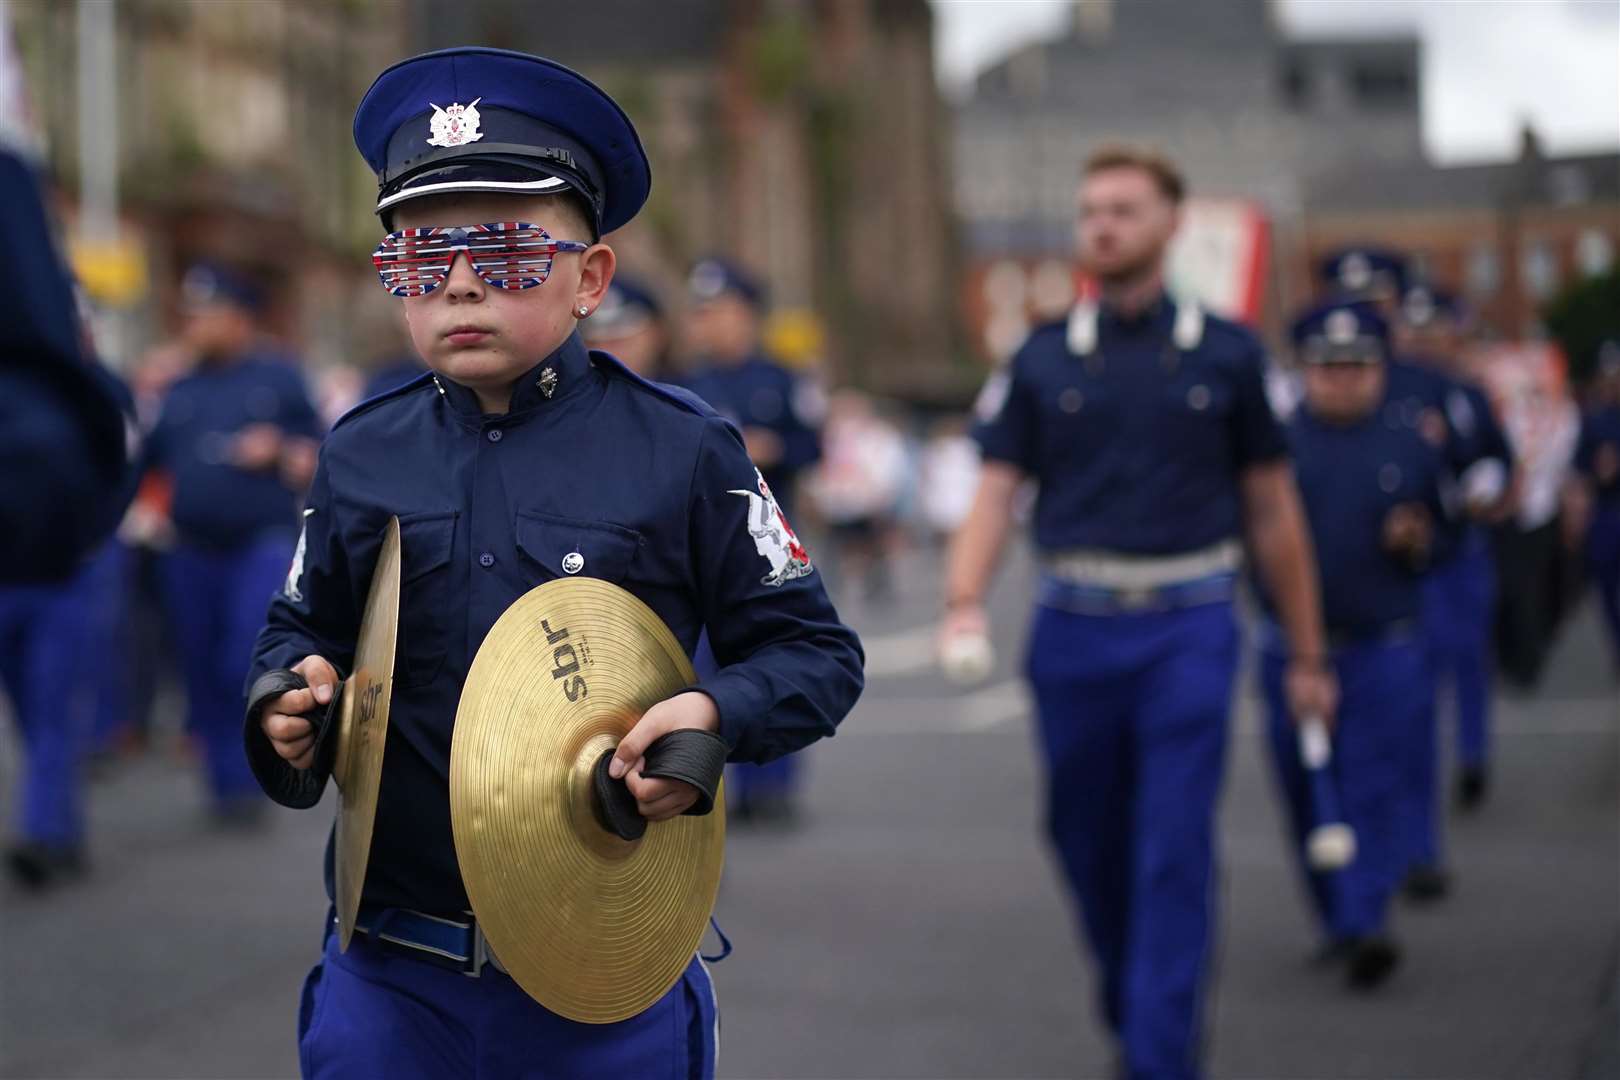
left=248, top=334, right=863, bottom=913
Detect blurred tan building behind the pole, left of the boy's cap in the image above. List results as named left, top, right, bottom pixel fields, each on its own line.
left=8, top=0, right=400, bottom=361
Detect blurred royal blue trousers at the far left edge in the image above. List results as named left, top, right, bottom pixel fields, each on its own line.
left=0, top=554, right=109, bottom=848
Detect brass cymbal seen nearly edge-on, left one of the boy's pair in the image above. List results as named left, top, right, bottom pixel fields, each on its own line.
left=332, top=518, right=400, bottom=952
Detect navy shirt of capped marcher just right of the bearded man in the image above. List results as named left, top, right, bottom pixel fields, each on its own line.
left=1267, top=392, right=1445, bottom=638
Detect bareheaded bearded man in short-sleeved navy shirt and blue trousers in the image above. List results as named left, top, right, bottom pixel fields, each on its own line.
left=941, top=147, right=1337, bottom=1078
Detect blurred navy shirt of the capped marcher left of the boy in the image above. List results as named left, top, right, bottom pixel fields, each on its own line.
left=146, top=353, right=321, bottom=549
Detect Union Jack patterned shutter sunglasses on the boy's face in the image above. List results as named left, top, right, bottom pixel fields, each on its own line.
left=371, top=222, right=590, bottom=298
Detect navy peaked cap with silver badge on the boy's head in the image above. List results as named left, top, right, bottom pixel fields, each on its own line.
left=355, top=47, right=653, bottom=233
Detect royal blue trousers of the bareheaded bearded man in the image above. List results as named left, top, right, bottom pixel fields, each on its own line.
left=1027, top=602, right=1238, bottom=1080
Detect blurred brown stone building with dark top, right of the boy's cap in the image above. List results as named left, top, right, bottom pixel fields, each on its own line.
left=407, top=0, right=956, bottom=397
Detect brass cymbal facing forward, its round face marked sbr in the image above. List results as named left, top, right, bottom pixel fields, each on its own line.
left=450, top=578, right=726, bottom=1023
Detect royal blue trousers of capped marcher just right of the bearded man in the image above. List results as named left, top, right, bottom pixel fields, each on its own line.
left=1260, top=640, right=1429, bottom=941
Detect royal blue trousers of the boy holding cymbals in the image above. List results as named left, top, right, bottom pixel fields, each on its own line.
left=298, top=933, right=719, bottom=1080
